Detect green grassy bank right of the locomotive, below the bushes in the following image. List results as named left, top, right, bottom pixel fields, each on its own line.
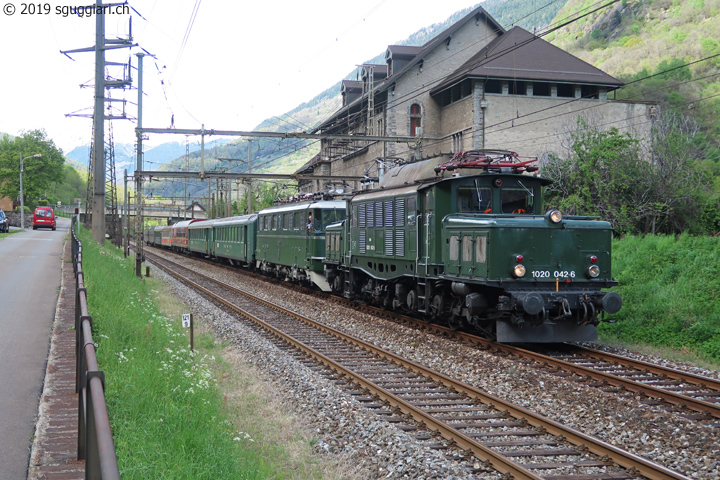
left=599, top=235, right=720, bottom=368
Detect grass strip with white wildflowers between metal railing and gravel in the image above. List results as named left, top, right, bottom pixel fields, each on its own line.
left=80, top=229, right=334, bottom=479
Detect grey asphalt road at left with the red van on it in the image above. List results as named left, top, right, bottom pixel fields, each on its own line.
left=0, top=218, right=70, bottom=480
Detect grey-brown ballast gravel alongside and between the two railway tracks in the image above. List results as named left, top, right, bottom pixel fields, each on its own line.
left=148, top=251, right=720, bottom=480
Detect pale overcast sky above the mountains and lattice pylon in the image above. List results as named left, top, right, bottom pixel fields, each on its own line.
left=0, top=0, right=478, bottom=152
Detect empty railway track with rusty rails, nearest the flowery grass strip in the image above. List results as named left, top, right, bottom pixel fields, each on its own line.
left=146, top=252, right=685, bottom=480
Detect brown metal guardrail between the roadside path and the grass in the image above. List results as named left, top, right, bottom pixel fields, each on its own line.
left=70, top=217, right=120, bottom=480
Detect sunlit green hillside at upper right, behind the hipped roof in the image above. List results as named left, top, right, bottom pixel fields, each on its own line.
left=545, top=0, right=720, bottom=152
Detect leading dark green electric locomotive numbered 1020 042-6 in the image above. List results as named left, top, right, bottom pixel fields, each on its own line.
left=324, top=151, right=622, bottom=342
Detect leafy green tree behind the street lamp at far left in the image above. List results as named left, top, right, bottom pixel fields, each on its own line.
left=0, top=130, right=65, bottom=208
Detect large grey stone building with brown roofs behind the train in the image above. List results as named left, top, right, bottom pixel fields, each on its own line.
left=296, top=7, right=652, bottom=192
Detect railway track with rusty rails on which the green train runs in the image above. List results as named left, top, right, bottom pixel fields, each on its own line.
left=143, top=246, right=720, bottom=428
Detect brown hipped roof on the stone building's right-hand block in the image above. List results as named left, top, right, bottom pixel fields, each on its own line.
left=430, top=27, right=623, bottom=94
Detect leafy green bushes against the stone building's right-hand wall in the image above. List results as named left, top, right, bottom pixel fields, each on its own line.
left=543, top=112, right=709, bottom=233
